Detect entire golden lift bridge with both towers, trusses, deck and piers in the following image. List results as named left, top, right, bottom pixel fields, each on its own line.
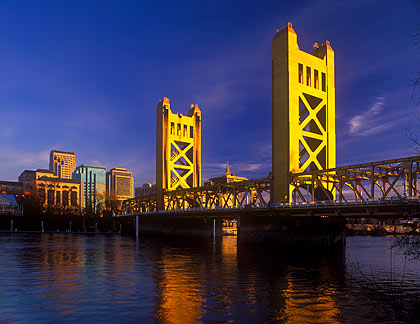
left=115, top=23, right=420, bottom=244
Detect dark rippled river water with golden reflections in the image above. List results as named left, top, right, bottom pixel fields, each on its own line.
left=0, top=233, right=420, bottom=324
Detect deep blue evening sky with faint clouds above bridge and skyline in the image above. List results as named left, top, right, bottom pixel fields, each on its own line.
left=0, top=0, right=420, bottom=186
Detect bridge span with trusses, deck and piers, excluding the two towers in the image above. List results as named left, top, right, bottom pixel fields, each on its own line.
left=114, top=156, right=420, bottom=247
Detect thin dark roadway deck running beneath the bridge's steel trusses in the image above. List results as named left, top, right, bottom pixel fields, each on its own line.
left=114, top=196, right=420, bottom=219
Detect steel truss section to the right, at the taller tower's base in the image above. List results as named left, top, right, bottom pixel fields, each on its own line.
left=290, top=156, right=420, bottom=203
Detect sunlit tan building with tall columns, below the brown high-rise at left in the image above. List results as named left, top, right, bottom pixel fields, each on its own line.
left=19, top=169, right=80, bottom=213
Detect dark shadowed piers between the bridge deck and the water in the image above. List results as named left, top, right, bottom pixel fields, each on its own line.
left=133, top=213, right=346, bottom=247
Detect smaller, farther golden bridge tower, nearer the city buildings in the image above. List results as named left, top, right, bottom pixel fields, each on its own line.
left=156, top=97, right=201, bottom=210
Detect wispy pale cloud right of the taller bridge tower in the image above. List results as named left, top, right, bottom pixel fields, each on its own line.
left=349, top=96, right=390, bottom=136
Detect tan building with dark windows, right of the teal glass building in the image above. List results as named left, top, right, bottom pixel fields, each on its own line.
left=106, top=168, right=134, bottom=208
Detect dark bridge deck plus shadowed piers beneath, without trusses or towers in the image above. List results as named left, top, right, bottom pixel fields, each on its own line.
left=114, top=197, right=420, bottom=248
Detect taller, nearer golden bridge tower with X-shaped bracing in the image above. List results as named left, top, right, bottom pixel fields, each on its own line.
left=270, top=23, right=336, bottom=202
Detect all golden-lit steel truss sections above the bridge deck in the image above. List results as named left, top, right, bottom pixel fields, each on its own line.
left=122, top=156, right=420, bottom=214
